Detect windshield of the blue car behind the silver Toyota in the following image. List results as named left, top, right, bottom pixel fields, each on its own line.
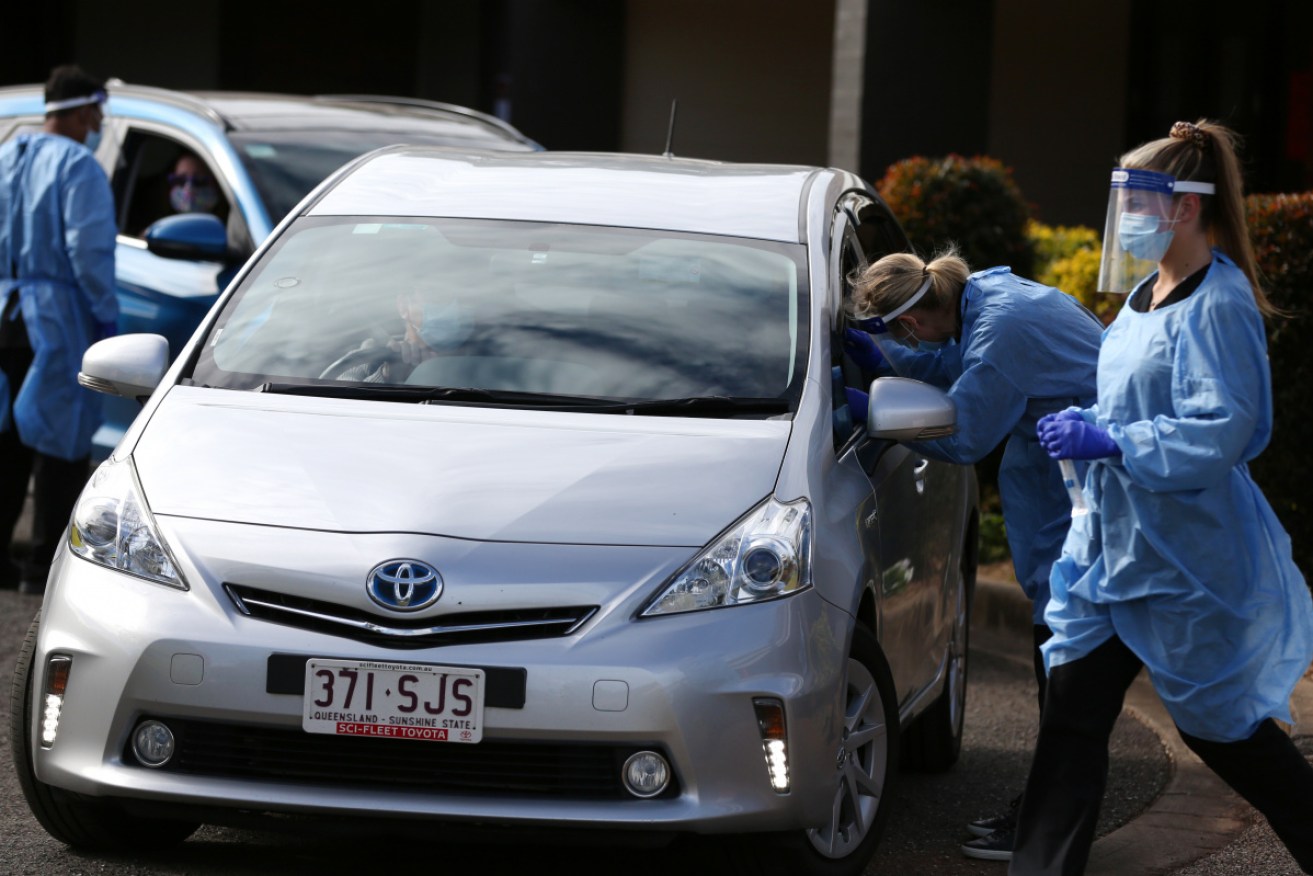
left=230, top=133, right=528, bottom=223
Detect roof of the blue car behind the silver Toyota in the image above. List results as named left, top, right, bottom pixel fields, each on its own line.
left=0, top=80, right=542, bottom=150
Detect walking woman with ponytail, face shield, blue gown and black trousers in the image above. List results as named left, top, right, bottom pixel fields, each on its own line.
left=1008, top=121, right=1313, bottom=876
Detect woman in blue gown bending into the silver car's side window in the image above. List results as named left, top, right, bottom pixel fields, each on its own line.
left=846, top=242, right=1103, bottom=860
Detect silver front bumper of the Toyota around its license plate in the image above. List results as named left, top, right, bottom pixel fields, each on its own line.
left=33, top=538, right=851, bottom=833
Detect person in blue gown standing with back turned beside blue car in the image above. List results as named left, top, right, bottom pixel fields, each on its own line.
left=0, top=66, right=118, bottom=592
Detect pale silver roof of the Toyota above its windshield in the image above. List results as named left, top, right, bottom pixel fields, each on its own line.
left=305, top=146, right=838, bottom=243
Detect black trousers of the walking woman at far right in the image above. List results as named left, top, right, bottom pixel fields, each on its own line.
left=1007, top=637, right=1313, bottom=876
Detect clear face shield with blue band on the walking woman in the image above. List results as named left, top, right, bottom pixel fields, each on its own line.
left=1098, top=167, right=1216, bottom=294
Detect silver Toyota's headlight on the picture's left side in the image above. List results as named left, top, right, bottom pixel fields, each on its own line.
left=68, top=458, right=186, bottom=590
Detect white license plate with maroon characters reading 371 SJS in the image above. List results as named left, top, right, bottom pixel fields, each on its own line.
left=301, top=658, right=484, bottom=742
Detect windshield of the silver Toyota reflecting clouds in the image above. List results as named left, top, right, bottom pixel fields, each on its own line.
left=190, top=217, right=807, bottom=416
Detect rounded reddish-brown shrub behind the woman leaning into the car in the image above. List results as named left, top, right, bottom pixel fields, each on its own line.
left=876, top=155, right=1033, bottom=277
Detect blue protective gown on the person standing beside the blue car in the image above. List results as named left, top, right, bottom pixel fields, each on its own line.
left=0, top=134, right=118, bottom=460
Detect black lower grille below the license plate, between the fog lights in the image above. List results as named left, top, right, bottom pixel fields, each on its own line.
left=123, top=717, right=676, bottom=799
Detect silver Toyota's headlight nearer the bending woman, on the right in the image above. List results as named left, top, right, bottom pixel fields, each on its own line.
left=642, top=499, right=811, bottom=616
